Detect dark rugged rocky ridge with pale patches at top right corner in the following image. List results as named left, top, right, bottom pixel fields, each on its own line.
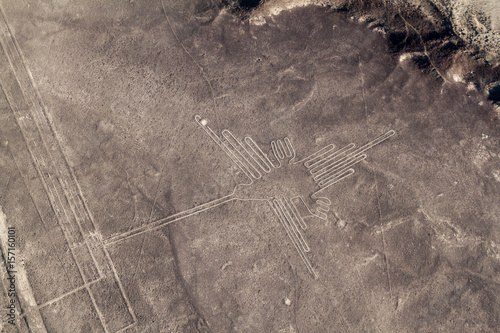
left=225, top=0, right=500, bottom=119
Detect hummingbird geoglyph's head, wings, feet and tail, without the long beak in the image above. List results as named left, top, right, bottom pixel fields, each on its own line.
left=195, top=115, right=395, bottom=278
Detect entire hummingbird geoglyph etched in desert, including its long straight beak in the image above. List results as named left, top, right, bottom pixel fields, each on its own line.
left=105, top=115, right=395, bottom=279
